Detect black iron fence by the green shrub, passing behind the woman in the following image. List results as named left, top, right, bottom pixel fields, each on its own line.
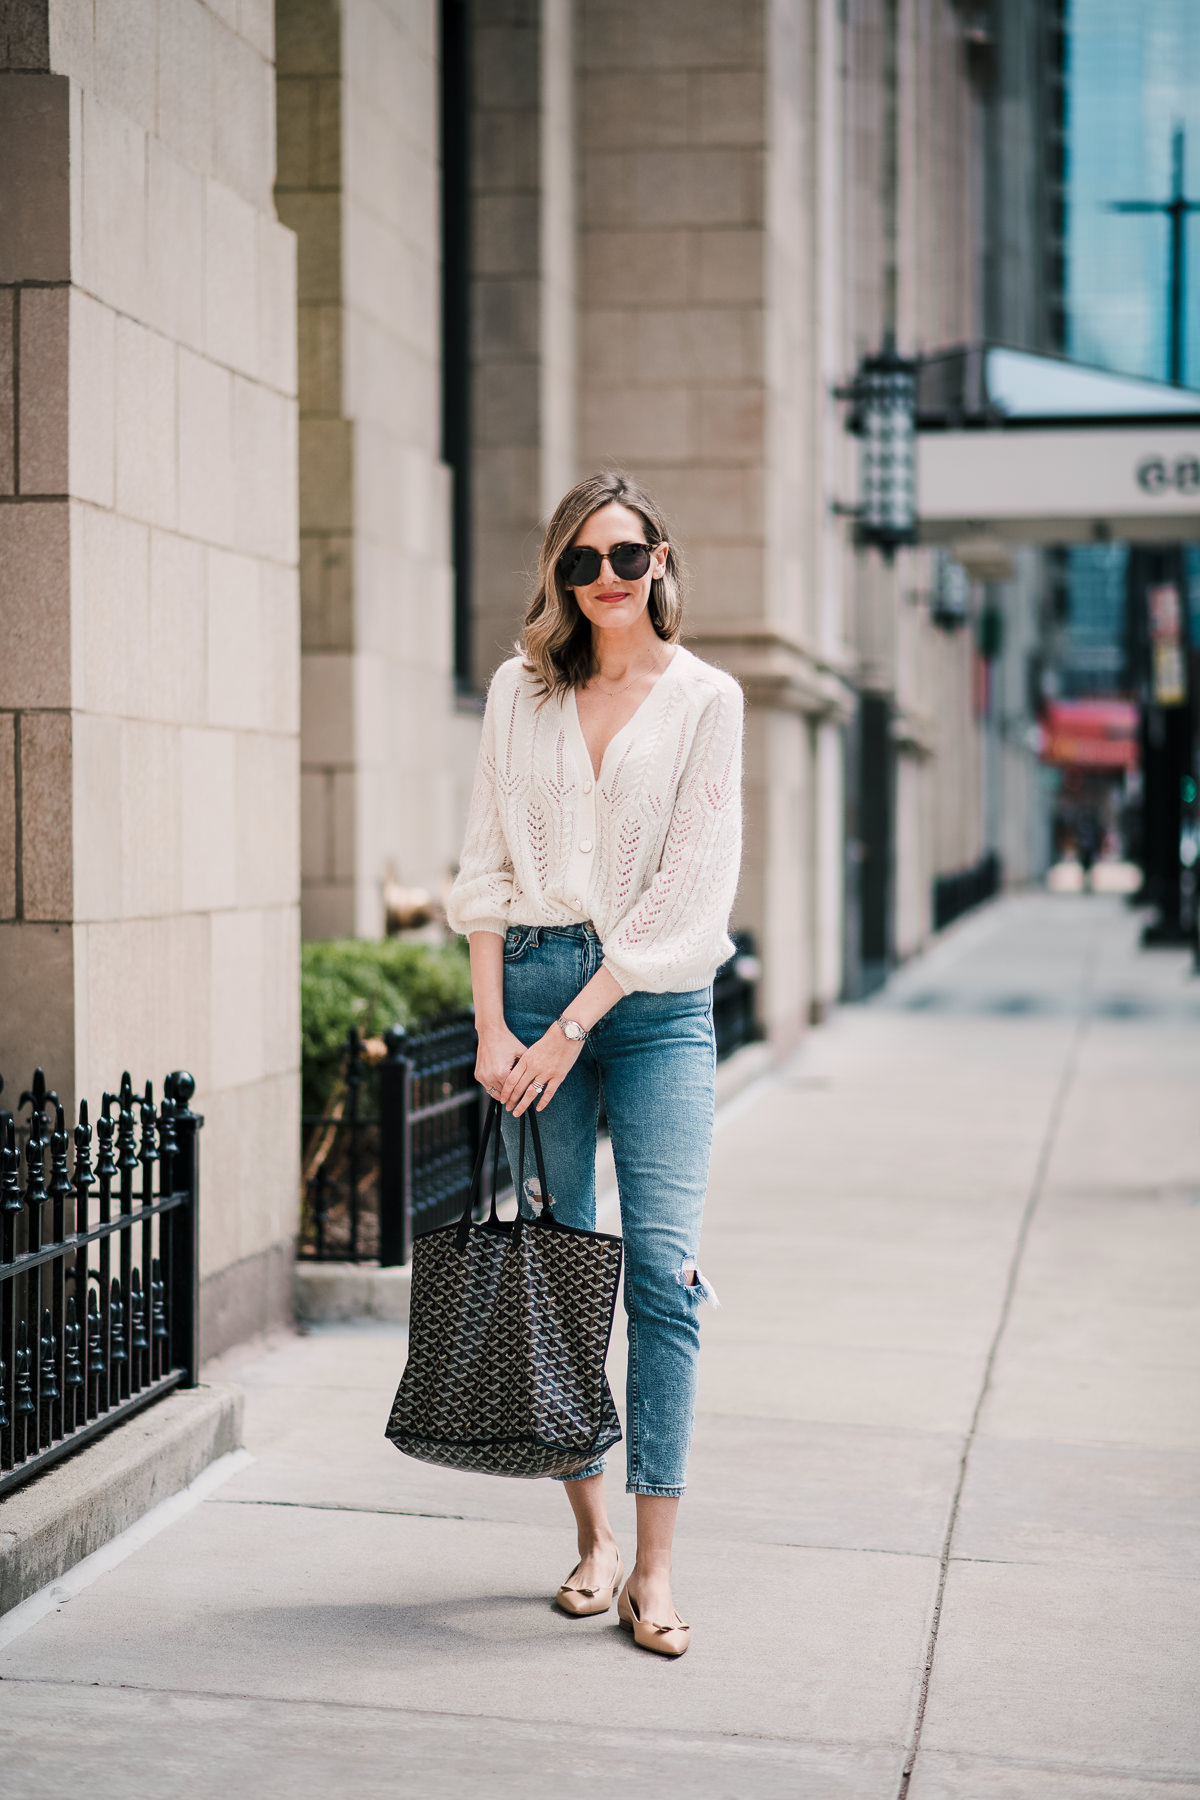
left=299, top=932, right=759, bottom=1267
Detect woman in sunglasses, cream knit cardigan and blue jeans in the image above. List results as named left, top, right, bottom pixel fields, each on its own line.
left=448, top=475, right=741, bottom=1656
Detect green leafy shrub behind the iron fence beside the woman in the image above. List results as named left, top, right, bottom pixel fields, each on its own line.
left=300, top=938, right=471, bottom=1112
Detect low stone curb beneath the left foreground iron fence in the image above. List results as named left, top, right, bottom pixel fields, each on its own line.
left=0, top=1384, right=243, bottom=1615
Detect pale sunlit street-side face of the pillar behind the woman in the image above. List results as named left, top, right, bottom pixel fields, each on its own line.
left=766, top=0, right=855, bottom=1019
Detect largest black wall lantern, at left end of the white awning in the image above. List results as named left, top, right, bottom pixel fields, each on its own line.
left=837, top=335, right=918, bottom=562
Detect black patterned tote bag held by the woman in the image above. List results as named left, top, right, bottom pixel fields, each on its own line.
left=387, top=1100, right=622, bottom=1478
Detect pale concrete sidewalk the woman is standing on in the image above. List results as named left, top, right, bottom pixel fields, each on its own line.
left=0, top=896, right=1200, bottom=1800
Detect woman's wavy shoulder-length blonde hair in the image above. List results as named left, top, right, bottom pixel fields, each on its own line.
left=516, top=470, right=684, bottom=698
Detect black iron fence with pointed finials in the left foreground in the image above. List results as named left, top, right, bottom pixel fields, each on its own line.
left=0, top=1069, right=203, bottom=1494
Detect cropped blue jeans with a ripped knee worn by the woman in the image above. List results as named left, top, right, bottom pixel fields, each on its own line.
left=504, top=925, right=716, bottom=1496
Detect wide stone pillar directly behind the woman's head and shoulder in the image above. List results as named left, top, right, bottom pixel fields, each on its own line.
left=578, top=0, right=847, bottom=1048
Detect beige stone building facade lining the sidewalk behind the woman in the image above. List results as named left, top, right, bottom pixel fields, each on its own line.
left=0, top=0, right=982, bottom=1350
